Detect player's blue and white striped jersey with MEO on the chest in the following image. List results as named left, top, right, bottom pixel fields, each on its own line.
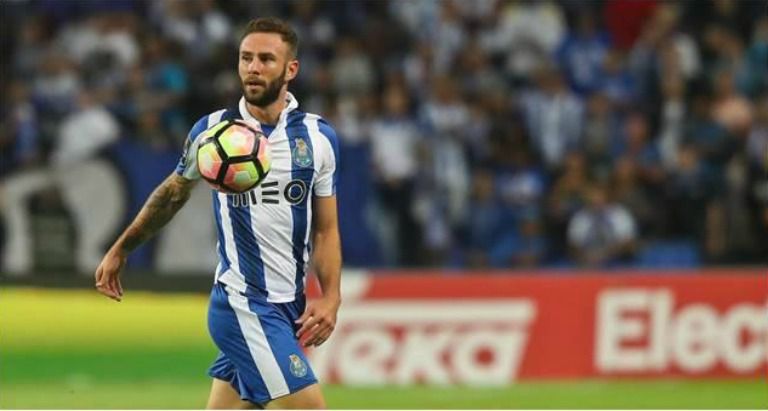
left=176, top=93, right=339, bottom=303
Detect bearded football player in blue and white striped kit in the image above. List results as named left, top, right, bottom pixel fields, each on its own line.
left=95, top=18, right=341, bottom=409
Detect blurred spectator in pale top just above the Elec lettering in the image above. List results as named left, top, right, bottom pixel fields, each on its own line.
left=568, top=184, right=637, bottom=267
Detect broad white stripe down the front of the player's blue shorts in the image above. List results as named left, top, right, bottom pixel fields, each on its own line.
left=227, top=292, right=290, bottom=398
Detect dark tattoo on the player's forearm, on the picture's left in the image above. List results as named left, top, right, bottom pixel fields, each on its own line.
left=122, top=177, right=191, bottom=251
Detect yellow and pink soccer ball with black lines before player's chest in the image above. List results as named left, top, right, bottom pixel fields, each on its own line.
left=197, top=120, right=271, bottom=194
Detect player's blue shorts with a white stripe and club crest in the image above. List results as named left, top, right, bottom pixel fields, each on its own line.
left=208, top=283, right=317, bottom=405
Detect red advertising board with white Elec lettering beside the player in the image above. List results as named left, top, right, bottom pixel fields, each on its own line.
left=311, top=270, right=768, bottom=385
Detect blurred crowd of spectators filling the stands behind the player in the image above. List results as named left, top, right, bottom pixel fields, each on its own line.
left=0, top=0, right=768, bottom=268
